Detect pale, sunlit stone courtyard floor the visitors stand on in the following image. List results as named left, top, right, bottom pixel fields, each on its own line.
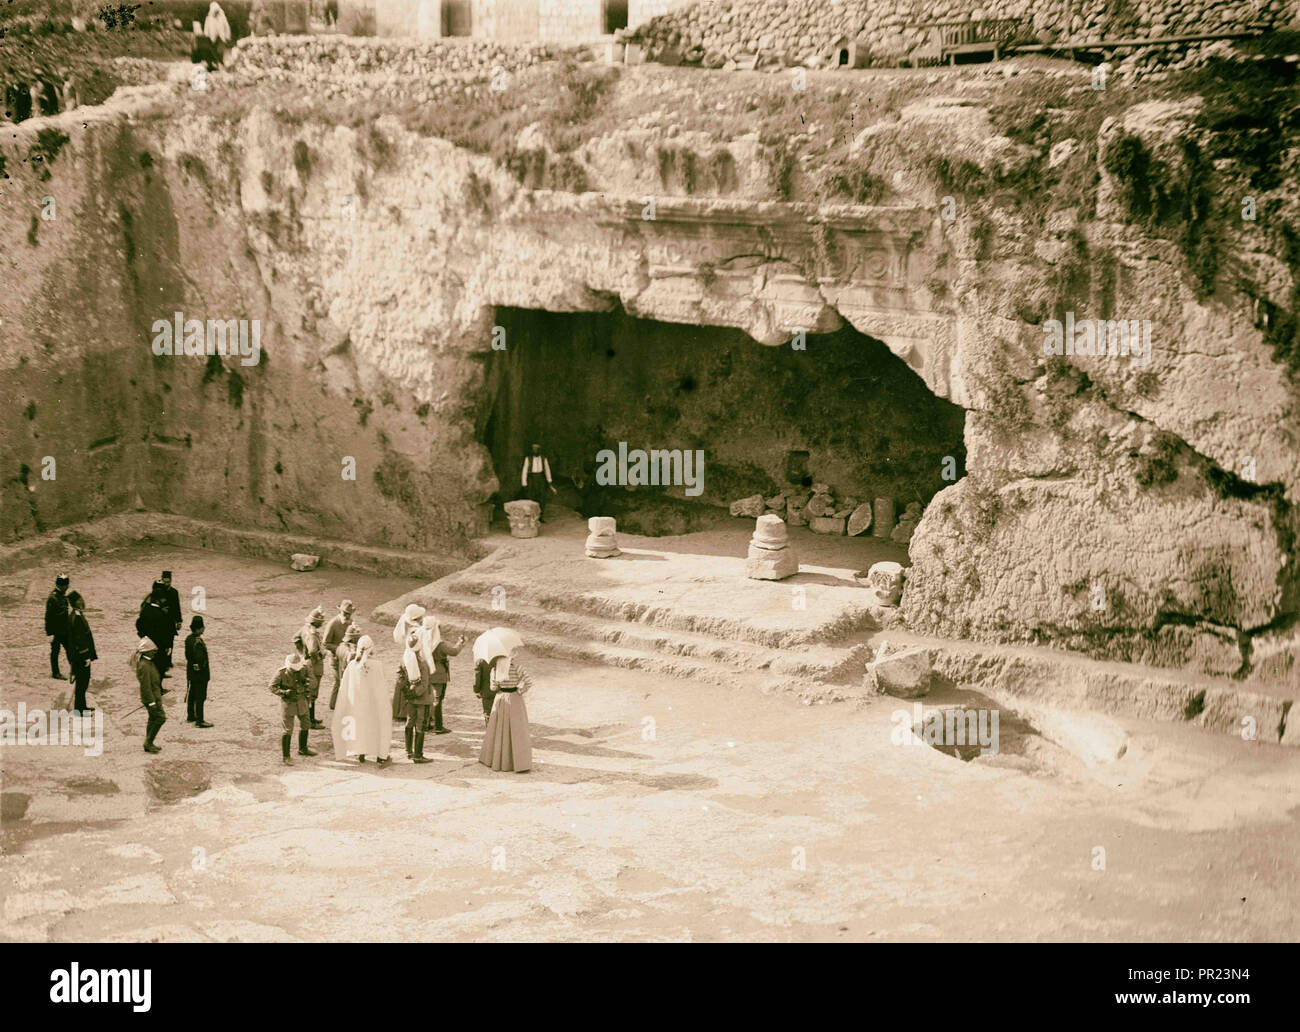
left=0, top=547, right=1300, bottom=941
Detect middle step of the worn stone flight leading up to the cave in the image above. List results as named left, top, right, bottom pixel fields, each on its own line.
left=432, top=593, right=862, bottom=682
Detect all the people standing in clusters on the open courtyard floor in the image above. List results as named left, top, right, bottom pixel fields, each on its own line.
left=46, top=571, right=532, bottom=772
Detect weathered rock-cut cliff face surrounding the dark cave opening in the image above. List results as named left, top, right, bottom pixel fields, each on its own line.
left=0, top=66, right=1300, bottom=675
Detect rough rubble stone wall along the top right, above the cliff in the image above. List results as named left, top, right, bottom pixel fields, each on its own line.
left=634, top=0, right=1300, bottom=61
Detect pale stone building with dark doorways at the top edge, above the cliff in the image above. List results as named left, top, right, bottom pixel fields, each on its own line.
left=338, top=0, right=688, bottom=43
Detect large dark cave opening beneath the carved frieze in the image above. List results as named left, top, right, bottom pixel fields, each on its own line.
left=478, top=308, right=966, bottom=543
